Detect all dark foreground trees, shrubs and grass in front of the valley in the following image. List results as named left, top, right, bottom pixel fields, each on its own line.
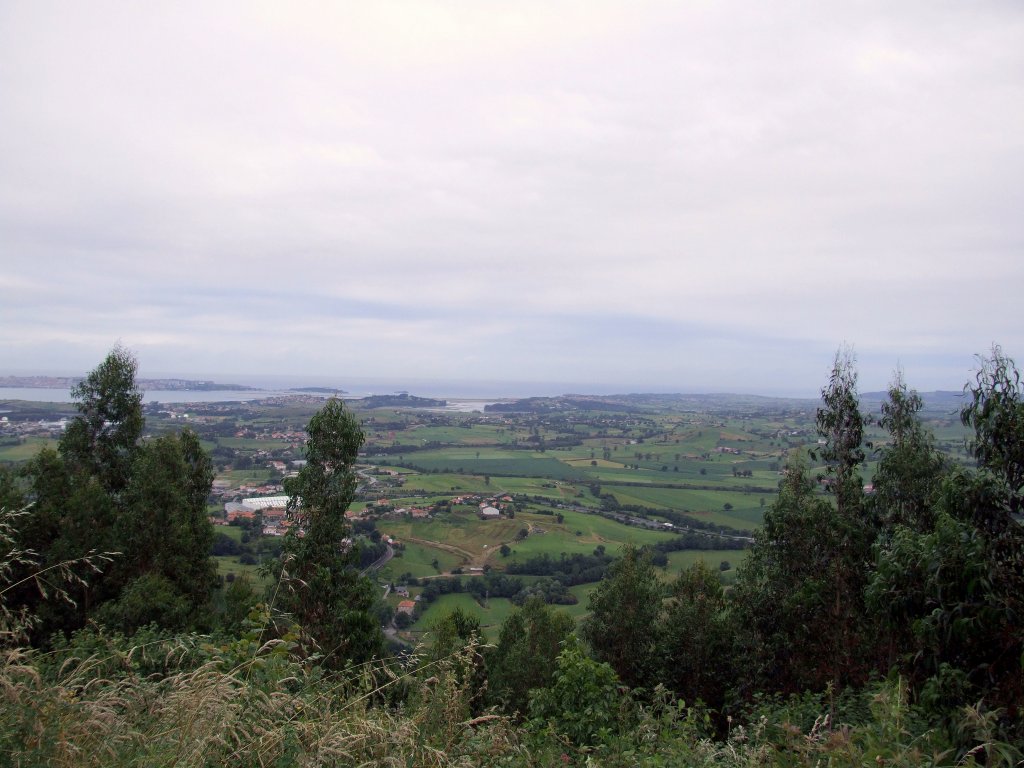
left=0, top=348, right=1024, bottom=766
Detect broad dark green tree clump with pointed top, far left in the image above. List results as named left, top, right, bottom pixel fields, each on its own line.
left=13, top=346, right=215, bottom=639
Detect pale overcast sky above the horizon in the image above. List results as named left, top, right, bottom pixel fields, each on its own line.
left=0, top=0, right=1024, bottom=394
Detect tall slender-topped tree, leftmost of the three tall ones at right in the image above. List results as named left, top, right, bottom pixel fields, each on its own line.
left=734, top=349, right=877, bottom=692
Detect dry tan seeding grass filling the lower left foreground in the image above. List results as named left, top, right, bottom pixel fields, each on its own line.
left=0, top=634, right=522, bottom=768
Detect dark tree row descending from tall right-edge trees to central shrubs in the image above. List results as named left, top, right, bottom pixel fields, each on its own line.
left=419, top=347, right=1024, bottom=761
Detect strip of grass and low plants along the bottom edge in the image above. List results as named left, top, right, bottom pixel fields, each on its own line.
left=0, top=636, right=1007, bottom=768
